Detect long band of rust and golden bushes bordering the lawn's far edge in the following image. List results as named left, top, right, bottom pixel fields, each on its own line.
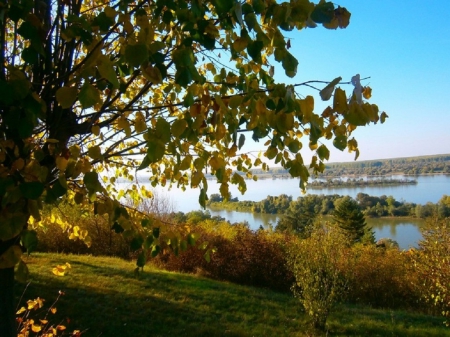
left=34, top=205, right=450, bottom=328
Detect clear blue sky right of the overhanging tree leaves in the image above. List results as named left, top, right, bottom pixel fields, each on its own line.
left=248, top=0, right=450, bottom=162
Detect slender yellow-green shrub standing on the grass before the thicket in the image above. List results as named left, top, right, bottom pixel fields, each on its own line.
left=288, top=225, right=350, bottom=331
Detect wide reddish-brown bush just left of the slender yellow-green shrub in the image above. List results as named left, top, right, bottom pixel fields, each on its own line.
left=154, top=222, right=293, bottom=291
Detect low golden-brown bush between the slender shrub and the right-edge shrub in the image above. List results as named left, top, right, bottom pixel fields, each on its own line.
left=341, top=245, right=418, bottom=308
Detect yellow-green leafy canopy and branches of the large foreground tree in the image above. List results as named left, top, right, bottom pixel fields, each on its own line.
left=0, top=0, right=387, bottom=334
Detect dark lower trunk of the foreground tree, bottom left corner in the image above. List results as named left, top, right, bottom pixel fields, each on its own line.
left=0, top=268, right=17, bottom=337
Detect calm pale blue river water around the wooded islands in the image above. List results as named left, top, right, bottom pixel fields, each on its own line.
left=121, top=175, right=450, bottom=249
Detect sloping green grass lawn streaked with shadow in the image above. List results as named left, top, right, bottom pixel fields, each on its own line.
left=16, top=254, right=450, bottom=337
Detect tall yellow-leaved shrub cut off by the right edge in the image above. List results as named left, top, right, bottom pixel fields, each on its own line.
left=410, top=218, right=450, bottom=326
